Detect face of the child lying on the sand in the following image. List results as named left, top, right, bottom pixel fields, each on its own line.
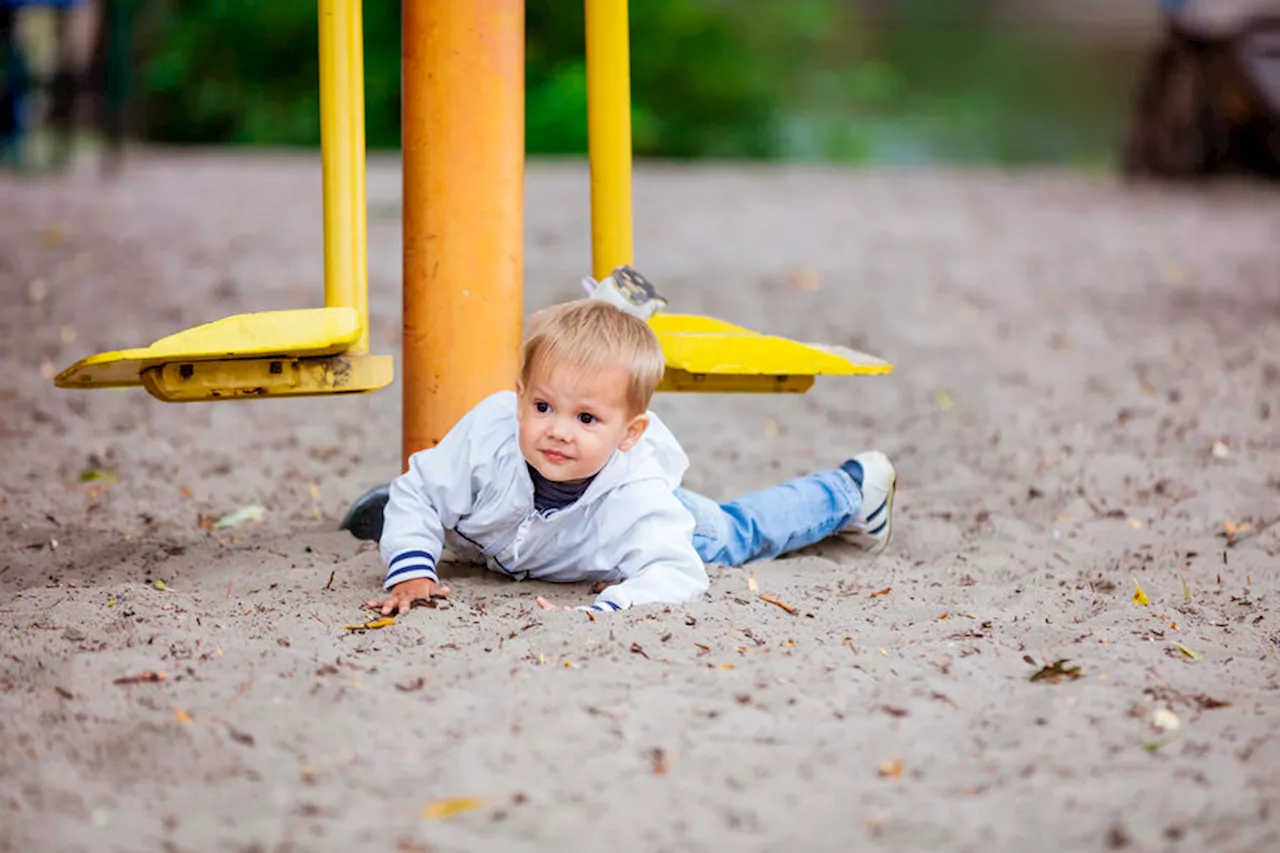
left=516, top=356, right=649, bottom=483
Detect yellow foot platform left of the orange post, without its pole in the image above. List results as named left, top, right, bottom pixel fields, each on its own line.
left=54, top=307, right=392, bottom=402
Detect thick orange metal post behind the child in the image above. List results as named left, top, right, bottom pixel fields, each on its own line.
left=402, top=0, right=525, bottom=465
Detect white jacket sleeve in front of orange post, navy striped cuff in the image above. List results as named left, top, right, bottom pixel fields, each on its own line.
left=378, top=401, right=489, bottom=589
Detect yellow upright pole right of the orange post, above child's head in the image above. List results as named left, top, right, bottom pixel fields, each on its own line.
left=586, top=0, right=635, bottom=279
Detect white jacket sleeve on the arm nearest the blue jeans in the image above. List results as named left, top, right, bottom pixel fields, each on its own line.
left=586, top=480, right=709, bottom=611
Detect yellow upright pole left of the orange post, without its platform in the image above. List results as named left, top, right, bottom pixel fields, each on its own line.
left=319, top=0, right=369, bottom=355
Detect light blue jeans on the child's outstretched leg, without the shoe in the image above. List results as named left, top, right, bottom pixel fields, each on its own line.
left=676, top=469, right=863, bottom=566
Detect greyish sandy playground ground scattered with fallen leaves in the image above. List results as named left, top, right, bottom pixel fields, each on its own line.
left=0, top=152, right=1280, bottom=852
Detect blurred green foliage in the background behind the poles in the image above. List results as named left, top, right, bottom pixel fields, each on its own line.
left=134, top=0, right=1139, bottom=163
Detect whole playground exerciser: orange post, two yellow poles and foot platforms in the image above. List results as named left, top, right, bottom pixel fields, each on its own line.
left=55, top=0, right=892, bottom=459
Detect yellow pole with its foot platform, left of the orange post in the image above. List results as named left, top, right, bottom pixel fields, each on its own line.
left=54, top=0, right=392, bottom=402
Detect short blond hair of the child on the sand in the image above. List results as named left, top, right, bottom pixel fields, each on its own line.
left=520, top=300, right=667, bottom=414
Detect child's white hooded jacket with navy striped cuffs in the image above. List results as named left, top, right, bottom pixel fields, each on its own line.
left=379, top=391, right=708, bottom=610
